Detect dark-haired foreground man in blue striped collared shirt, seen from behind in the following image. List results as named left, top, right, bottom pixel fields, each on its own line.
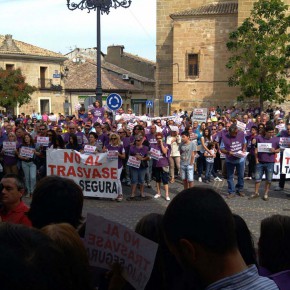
left=163, top=187, right=279, bottom=290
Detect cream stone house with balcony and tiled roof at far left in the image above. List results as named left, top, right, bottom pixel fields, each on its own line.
left=0, top=35, right=66, bottom=114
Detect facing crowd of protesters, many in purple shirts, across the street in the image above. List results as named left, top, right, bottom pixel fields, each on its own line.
left=0, top=101, right=290, bottom=201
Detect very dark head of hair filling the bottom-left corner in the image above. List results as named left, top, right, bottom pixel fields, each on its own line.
left=0, top=223, right=73, bottom=290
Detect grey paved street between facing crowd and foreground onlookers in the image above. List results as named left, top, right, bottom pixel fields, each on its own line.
left=80, top=180, right=290, bottom=238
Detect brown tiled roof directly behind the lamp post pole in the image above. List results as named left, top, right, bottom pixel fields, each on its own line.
left=64, top=60, right=138, bottom=91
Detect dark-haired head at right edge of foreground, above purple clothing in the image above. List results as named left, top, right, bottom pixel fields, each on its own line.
left=258, top=215, right=290, bottom=273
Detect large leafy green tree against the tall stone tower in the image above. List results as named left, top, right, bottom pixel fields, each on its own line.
left=226, top=0, right=290, bottom=109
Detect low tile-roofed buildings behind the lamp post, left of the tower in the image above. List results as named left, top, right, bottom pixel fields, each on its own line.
left=65, top=45, right=155, bottom=114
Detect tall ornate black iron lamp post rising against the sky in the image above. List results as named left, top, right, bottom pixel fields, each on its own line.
left=67, top=0, right=132, bottom=104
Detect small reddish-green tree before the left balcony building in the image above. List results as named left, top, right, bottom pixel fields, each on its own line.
left=0, top=68, right=36, bottom=109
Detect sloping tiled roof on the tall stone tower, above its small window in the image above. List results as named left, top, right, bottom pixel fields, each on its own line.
left=170, top=2, right=238, bottom=18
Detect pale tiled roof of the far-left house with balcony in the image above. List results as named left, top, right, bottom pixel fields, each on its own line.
left=0, top=35, right=64, bottom=58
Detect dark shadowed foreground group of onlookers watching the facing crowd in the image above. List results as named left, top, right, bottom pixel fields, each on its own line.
left=0, top=174, right=290, bottom=290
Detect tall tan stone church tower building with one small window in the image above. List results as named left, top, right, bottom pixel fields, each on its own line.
left=156, top=0, right=289, bottom=113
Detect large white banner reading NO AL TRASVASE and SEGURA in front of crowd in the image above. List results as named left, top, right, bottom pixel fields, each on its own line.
left=46, top=149, right=118, bottom=198
